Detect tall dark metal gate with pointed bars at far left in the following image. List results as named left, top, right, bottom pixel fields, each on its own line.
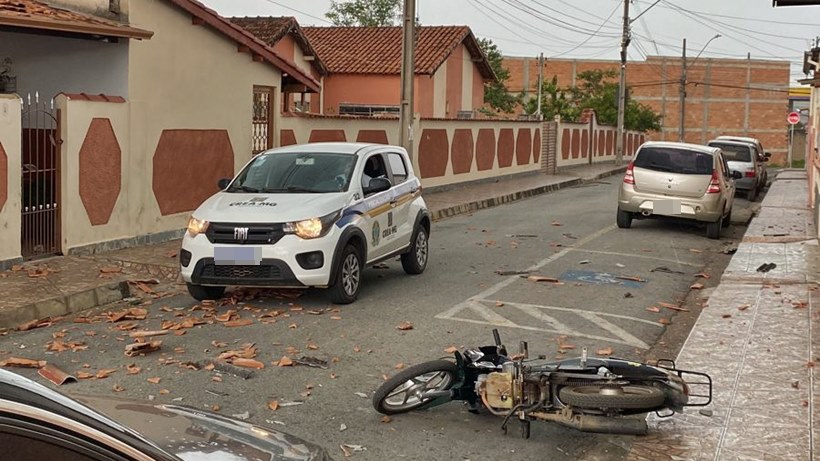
left=21, top=93, right=62, bottom=259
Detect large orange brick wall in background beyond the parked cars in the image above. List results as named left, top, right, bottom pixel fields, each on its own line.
left=504, top=56, right=789, bottom=154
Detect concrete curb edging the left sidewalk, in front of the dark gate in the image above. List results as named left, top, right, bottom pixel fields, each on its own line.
left=0, top=280, right=131, bottom=329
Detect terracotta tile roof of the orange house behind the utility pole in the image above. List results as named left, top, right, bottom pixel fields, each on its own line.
left=302, top=26, right=495, bottom=79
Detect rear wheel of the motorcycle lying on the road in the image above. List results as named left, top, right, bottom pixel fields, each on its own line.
left=559, top=386, right=666, bottom=410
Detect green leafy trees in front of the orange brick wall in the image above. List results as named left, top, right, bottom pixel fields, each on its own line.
left=525, top=70, right=661, bottom=131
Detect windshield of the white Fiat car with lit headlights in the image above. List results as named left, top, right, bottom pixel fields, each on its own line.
left=226, top=152, right=356, bottom=194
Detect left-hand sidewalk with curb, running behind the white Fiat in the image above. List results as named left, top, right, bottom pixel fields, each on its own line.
left=0, top=163, right=626, bottom=331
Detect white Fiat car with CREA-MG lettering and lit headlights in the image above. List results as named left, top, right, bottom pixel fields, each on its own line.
left=180, top=143, right=430, bottom=304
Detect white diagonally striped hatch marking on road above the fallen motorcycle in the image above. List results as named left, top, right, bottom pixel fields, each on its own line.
left=436, top=299, right=663, bottom=349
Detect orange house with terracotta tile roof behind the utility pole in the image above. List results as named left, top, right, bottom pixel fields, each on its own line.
left=272, top=26, right=496, bottom=119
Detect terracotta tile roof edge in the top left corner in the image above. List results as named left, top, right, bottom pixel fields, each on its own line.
left=0, top=0, right=153, bottom=39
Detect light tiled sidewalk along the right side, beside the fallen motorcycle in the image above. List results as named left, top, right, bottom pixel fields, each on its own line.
left=628, top=170, right=820, bottom=461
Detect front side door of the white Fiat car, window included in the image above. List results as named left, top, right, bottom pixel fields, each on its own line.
left=354, top=153, right=393, bottom=262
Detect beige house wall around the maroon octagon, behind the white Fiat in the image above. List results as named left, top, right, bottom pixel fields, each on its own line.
left=128, top=0, right=281, bottom=234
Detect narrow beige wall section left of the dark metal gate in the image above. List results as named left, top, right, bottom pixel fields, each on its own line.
left=0, top=94, right=22, bottom=262
